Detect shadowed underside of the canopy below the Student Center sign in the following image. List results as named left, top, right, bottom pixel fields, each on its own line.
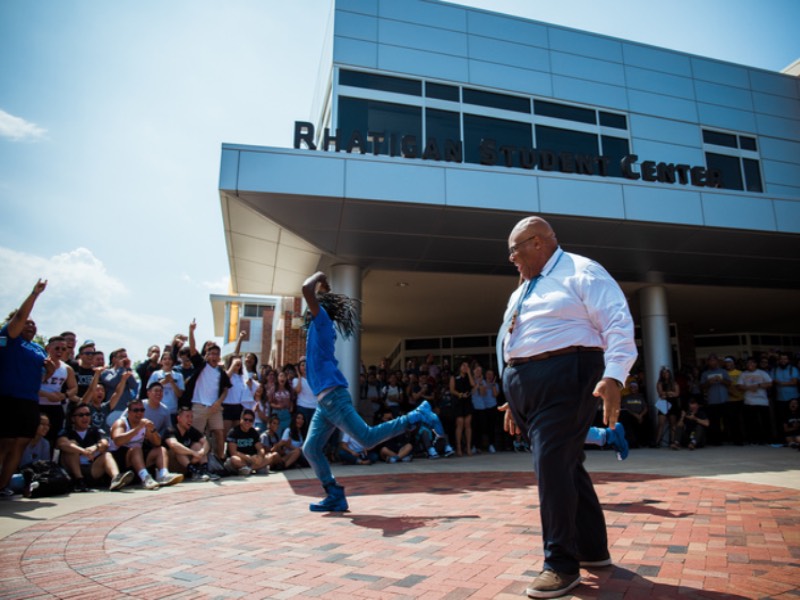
left=221, top=185, right=800, bottom=360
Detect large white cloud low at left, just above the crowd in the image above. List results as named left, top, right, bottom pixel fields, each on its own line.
left=0, top=247, right=174, bottom=358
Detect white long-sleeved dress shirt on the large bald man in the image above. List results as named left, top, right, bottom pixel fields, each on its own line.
left=504, top=248, right=637, bottom=382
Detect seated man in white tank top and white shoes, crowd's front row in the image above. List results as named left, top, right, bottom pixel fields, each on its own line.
left=110, top=398, right=183, bottom=490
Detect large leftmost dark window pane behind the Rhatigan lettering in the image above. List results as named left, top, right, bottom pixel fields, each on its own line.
left=338, top=96, right=424, bottom=156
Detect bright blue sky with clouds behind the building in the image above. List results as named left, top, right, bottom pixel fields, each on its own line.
left=0, top=0, right=800, bottom=359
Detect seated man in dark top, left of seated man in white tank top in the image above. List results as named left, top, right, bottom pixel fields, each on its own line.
left=57, top=402, right=133, bottom=492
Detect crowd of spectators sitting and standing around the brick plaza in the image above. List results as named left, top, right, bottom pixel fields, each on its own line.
left=0, top=281, right=800, bottom=496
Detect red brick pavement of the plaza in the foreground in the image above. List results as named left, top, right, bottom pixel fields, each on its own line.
left=0, top=468, right=800, bottom=600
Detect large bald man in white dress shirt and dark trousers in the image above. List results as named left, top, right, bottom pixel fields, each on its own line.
left=498, top=217, right=636, bottom=598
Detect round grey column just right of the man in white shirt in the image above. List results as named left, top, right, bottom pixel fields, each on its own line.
left=639, top=285, right=675, bottom=421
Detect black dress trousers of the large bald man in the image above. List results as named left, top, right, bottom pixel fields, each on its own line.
left=503, top=352, right=609, bottom=574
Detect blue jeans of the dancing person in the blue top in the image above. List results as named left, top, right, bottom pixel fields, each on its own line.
left=303, top=387, right=411, bottom=486
